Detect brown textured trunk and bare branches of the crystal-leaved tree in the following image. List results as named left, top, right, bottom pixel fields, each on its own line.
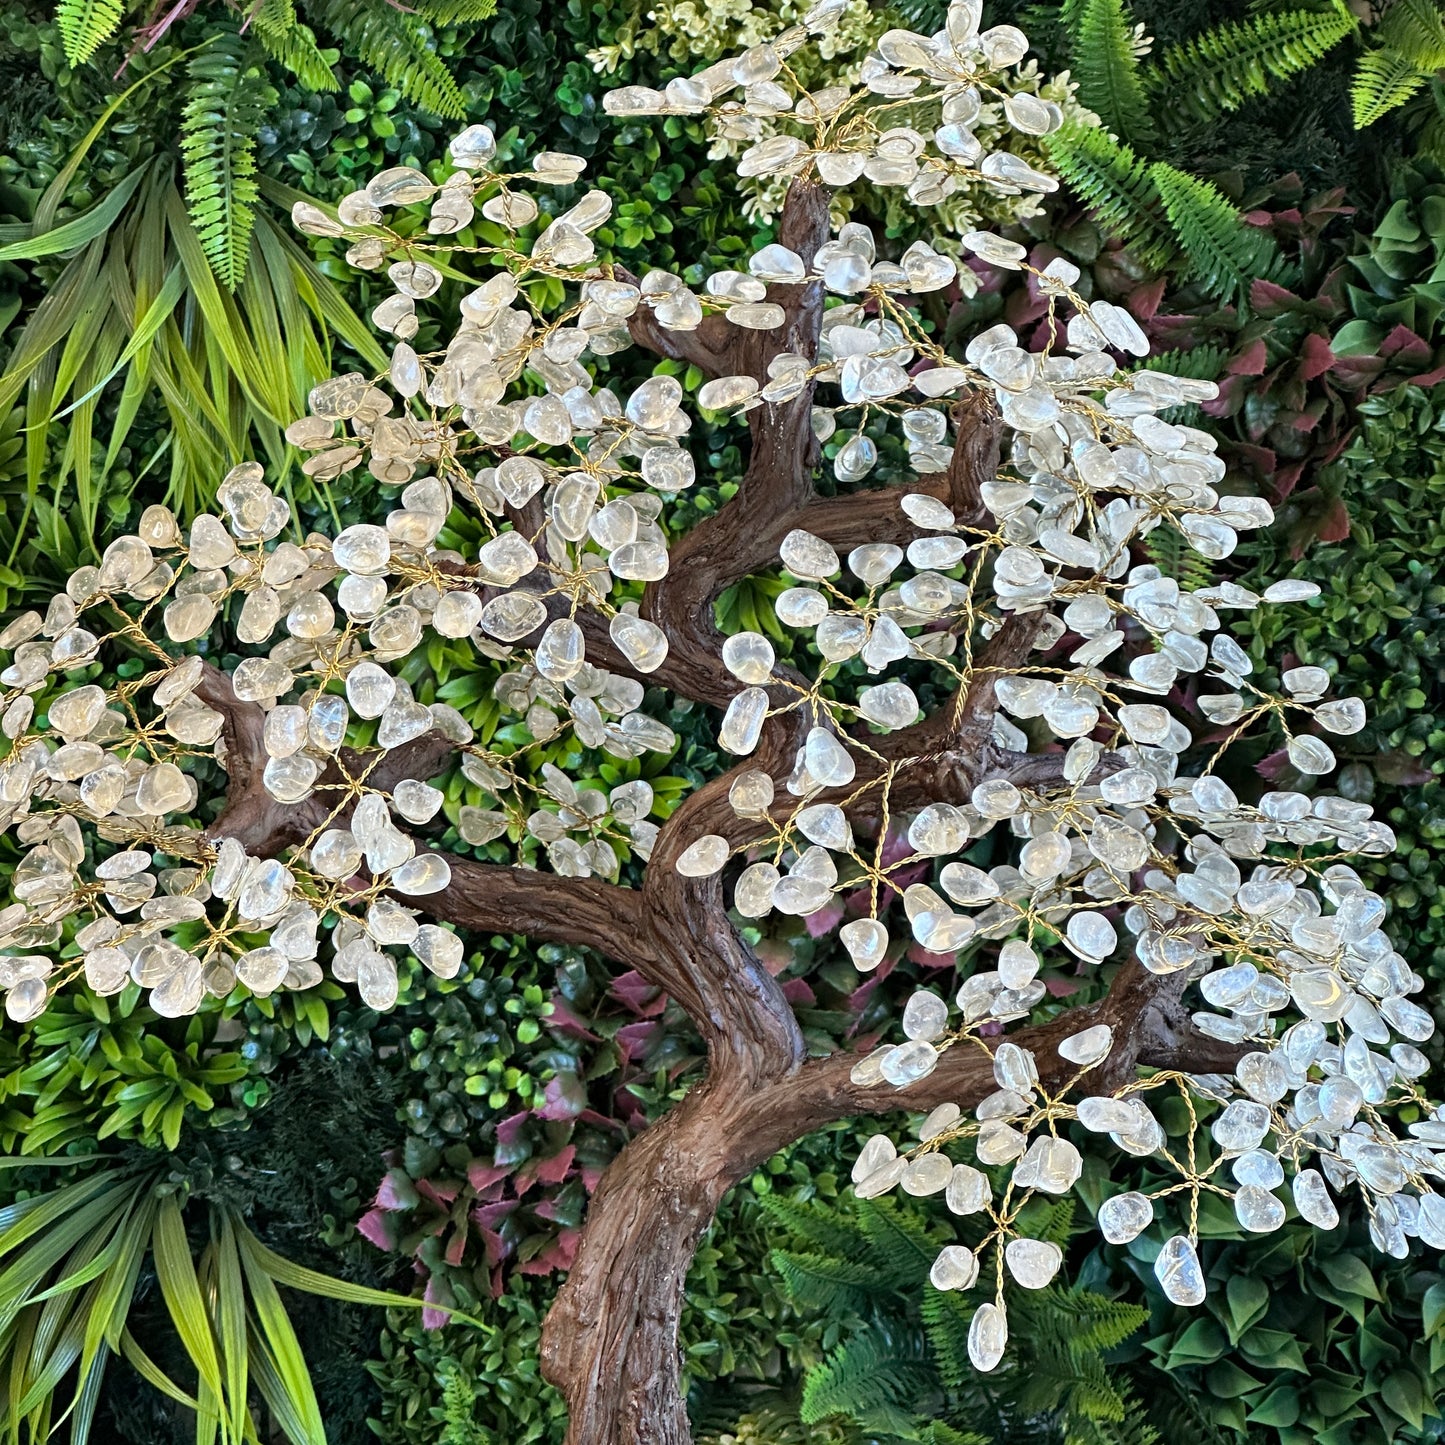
left=198, top=182, right=1240, bottom=1445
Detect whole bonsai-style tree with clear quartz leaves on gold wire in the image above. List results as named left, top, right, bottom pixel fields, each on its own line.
left=0, top=0, right=1445, bottom=1445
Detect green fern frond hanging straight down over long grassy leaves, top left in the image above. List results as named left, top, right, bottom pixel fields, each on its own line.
left=181, top=35, right=276, bottom=290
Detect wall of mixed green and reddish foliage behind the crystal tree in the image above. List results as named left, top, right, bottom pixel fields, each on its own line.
left=0, top=0, right=1445, bottom=1445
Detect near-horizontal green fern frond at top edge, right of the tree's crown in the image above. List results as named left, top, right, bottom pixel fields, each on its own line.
left=1146, top=0, right=1357, bottom=120
